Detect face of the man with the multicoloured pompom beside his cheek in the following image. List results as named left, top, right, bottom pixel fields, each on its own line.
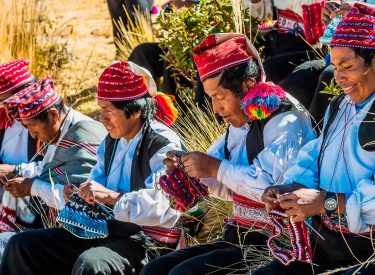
left=203, top=76, right=249, bottom=128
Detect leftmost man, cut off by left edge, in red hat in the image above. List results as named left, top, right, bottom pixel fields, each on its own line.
left=0, top=59, right=42, bottom=194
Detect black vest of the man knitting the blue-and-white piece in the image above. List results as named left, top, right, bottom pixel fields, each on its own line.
left=104, top=123, right=170, bottom=191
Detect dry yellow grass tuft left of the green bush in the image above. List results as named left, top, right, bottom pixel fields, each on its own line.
left=114, top=9, right=155, bottom=60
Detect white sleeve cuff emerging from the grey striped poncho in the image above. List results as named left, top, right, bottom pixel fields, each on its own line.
left=31, top=179, right=66, bottom=210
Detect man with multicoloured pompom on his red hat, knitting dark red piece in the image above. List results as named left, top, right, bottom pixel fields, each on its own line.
left=142, top=33, right=315, bottom=274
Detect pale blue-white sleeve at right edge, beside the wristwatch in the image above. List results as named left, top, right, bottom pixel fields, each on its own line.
left=345, top=179, right=375, bottom=233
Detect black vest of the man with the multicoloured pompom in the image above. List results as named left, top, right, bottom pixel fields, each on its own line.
left=224, top=99, right=297, bottom=165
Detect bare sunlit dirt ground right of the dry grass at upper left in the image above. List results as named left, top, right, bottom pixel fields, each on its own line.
left=45, top=0, right=116, bottom=117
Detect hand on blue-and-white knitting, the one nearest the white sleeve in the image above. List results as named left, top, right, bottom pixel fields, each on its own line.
left=78, top=181, right=122, bottom=205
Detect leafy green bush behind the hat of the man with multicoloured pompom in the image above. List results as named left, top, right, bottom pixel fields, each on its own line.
left=156, top=0, right=254, bottom=83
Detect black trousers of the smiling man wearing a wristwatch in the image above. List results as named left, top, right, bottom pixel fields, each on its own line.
left=253, top=218, right=374, bottom=275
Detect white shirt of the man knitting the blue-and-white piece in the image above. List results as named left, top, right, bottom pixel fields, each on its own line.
left=89, top=121, right=181, bottom=227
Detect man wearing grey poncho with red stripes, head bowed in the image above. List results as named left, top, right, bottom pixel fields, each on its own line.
left=0, top=77, right=106, bottom=256
